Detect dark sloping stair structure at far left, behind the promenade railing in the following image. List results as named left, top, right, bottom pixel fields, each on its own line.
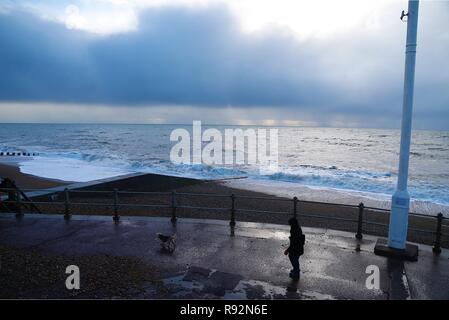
left=0, top=178, right=42, bottom=214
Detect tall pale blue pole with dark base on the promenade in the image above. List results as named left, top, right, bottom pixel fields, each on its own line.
left=375, top=0, right=419, bottom=260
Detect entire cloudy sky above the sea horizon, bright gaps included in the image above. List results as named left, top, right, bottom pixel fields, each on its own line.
left=0, top=0, right=449, bottom=130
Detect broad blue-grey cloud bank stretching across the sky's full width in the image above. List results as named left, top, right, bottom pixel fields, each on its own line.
left=0, top=2, right=449, bottom=129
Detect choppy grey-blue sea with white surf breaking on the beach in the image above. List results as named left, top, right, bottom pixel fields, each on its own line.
left=0, top=124, right=449, bottom=216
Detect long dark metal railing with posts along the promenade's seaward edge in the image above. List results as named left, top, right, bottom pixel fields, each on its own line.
left=0, top=188, right=449, bottom=255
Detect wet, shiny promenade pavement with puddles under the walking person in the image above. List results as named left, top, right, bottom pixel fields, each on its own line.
left=0, top=214, right=449, bottom=299
